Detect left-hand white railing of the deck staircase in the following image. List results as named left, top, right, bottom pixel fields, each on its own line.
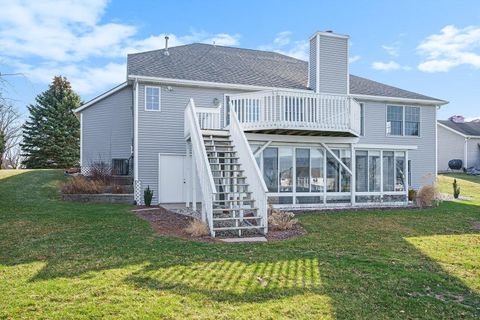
left=185, top=99, right=217, bottom=235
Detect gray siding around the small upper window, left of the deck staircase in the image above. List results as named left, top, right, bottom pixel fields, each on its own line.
left=138, top=83, right=246, bottom=203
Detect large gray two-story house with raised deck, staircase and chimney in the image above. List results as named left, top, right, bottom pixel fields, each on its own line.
left=76, top=32, right=447, bottom=234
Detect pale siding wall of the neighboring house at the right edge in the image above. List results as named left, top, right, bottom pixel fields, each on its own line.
left=437, top=126, right=465, bottom=172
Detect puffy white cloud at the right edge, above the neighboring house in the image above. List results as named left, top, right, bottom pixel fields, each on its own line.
left=417, top=25, right=480, bottom=72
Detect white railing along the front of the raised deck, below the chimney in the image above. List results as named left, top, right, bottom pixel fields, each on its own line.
left=230, top=90, right=361, bottom=135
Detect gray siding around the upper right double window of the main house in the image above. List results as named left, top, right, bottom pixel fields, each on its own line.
left=359, top=101, right=437, bottom=189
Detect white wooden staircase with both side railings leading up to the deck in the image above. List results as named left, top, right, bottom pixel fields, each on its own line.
left=185, top=99, right=268, bottom=237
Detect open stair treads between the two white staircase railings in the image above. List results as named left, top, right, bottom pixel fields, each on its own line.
left=202, top=131, right=263, bottom=237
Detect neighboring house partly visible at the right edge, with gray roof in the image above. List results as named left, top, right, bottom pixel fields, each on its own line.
left=437, top=119, right=480, bottom=172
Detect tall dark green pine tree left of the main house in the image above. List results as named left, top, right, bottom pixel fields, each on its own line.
left=21, top=76, right=81, bottom=168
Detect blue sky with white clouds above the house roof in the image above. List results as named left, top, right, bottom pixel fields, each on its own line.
left=0, top=0, right=480, bottom=118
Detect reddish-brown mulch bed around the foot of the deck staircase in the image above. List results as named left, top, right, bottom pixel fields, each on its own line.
left=133, top=206, right=306, bottom=242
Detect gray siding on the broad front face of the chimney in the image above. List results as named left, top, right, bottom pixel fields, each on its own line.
left=318, top=35, right=348, bottom=94
